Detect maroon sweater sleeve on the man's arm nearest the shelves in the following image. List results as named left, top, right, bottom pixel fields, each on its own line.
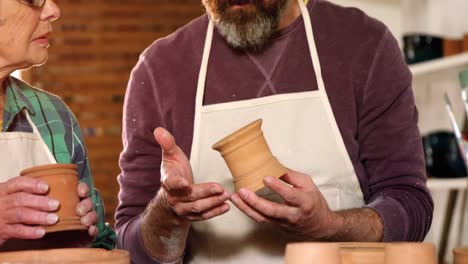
left=358, top=31, right=433, bottom=241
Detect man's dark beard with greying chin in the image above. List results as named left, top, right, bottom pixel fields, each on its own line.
left=205, top=0, right=287, bottom=51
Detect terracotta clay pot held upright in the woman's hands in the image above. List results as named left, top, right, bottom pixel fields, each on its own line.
left=20, top=164, right=86, bottom=233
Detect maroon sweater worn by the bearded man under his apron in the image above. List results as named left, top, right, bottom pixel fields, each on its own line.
left=116, top=0, right=433, bottom=263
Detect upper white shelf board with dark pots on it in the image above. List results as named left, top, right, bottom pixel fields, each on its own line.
left=410, top=52, right=468, bottom=77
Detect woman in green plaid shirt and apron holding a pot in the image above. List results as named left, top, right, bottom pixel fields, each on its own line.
left=0, top=0, right=115, bottom=251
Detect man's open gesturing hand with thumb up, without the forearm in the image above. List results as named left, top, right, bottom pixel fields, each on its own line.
left=154, top=128, right=230, bottom=222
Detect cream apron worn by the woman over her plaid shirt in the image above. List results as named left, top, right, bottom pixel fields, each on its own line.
left=0, top=110, right=57, bottom=182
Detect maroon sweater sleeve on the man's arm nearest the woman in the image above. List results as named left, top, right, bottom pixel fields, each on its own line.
left=116, top=54, right=167, bottom=263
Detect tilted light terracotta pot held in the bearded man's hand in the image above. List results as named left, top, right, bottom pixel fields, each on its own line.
left=213, top=119, right=287, bottom=192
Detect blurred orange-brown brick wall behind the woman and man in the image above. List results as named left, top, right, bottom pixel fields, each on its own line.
left=25, top=0, right=203, bottom=223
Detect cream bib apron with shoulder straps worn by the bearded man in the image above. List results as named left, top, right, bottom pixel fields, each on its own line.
left=187, top=0, right=364, bottom=264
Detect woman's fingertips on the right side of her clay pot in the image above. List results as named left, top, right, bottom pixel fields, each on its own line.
left=76, top=182, right=98, bottom=238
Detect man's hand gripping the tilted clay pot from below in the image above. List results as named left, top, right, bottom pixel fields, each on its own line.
left=231, top=170, right=340, bottom=240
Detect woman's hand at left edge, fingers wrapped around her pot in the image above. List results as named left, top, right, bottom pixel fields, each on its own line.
left=0, top=176, right=59, bottom=246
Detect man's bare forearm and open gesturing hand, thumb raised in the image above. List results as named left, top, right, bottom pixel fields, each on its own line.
left=140, top=128, right=230, bottom=262
